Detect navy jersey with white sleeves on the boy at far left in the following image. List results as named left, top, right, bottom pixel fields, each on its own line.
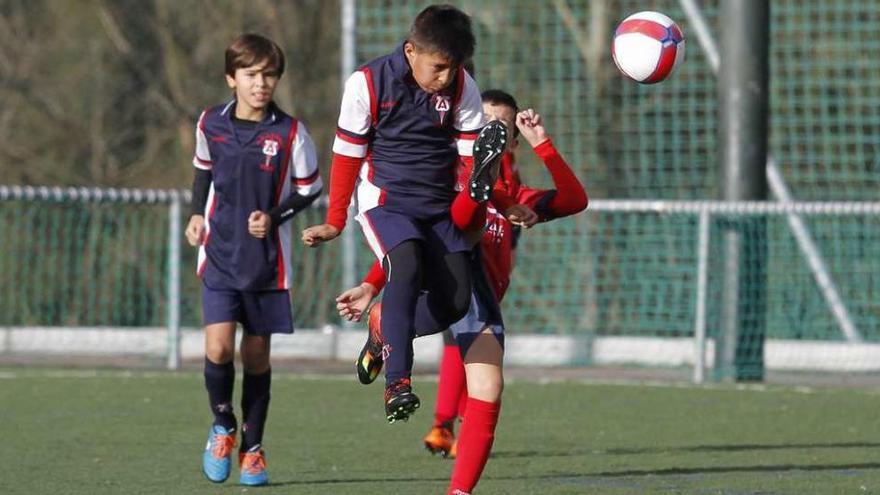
left=193, top=100, right=322, bottom=291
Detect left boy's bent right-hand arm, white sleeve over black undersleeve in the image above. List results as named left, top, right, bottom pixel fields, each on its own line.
left=269, top=123, right=324, bottom=226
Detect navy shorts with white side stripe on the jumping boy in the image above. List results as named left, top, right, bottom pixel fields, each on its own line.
left=357, top=206, right=473, bottom=261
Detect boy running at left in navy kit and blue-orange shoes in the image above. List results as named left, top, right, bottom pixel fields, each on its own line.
left=186, top=34, right=322, bottom=485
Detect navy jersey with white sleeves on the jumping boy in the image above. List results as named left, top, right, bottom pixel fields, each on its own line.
left=333, top=45, right=483, bottom=218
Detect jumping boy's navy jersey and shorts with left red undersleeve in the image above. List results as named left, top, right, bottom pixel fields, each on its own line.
left=327, top=45, right=483, bottom=259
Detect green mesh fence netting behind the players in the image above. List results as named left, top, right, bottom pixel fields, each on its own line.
left=0, top=0, right=880, bottom=372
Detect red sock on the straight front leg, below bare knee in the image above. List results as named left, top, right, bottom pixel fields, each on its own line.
left=446, top=397, right=501, bottom=495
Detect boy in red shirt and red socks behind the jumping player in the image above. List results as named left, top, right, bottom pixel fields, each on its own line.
left=337, top=90, right=587, bottom=493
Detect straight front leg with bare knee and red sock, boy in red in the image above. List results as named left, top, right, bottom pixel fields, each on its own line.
left=447, top=329, right=504, bottom=494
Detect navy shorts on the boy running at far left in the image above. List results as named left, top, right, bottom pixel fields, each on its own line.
left=202, top=283, right=293, bottom=335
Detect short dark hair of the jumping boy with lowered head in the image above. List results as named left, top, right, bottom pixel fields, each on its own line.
left=406, top=4, right=476, bottom=65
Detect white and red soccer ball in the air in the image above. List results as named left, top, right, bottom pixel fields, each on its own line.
left=611, top=10, right=684, bottom=84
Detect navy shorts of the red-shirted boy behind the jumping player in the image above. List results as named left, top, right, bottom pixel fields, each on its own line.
left=449, top=246, right=504, bottom=357
